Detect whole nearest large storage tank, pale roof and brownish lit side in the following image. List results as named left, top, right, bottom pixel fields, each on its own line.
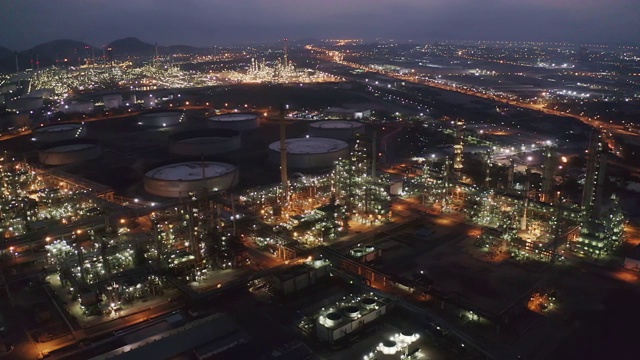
left=144, top=161, right=238, bottom=198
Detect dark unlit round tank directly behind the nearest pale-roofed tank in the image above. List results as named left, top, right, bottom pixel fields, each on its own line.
left=169, top=129, right=242, bottom=156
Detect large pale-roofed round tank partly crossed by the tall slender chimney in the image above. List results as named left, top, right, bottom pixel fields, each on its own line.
left=269, top=138, right=349, bottom=169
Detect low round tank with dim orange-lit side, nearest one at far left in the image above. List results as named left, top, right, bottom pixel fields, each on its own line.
left=38, top=139, right=102, bottom=165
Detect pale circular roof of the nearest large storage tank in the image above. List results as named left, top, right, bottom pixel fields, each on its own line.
left=145, top=161, right=236, bottom=181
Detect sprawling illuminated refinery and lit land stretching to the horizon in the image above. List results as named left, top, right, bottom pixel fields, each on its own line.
left=0, top=7, right=640, bottom=360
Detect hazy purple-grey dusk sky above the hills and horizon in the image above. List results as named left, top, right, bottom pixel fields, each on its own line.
left=0, top=0, right=640, bottom=50
